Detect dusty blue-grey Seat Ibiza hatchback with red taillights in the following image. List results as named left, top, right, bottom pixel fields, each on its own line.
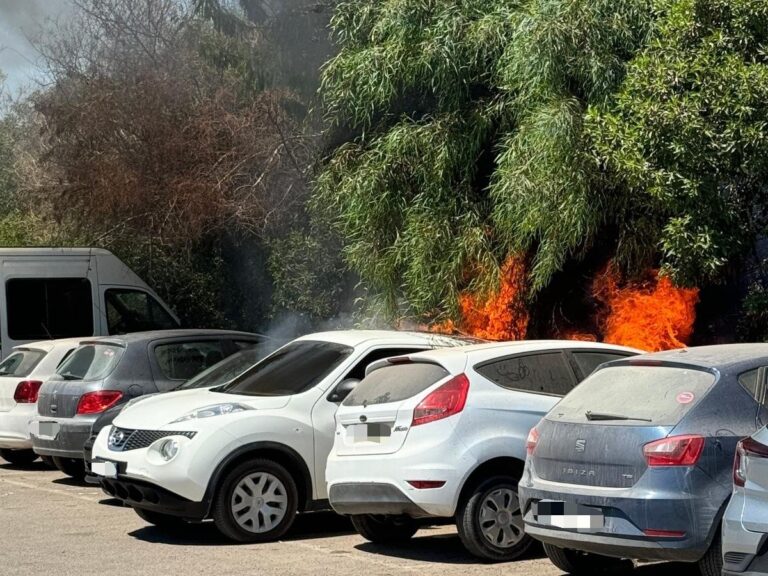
left=519, top=344, right=768, bottom=576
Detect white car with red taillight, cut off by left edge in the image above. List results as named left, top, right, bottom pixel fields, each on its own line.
left=0, top=338, right=82, bottom=464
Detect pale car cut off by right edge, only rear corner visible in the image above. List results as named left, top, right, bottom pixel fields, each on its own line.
left=723, top=428, right=768, bottom=576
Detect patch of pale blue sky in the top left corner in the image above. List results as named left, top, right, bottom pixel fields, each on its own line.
left=0, top=0, right=71, bottom=95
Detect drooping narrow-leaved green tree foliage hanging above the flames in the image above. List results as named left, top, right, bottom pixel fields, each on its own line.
left=315, top=0, right=655, bottom=316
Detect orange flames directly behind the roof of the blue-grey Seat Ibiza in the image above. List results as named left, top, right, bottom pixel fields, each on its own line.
left=593, top=265, right=699, bottom=352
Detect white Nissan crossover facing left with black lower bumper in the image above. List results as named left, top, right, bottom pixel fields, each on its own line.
left=91, top=330, right=464, bottom=542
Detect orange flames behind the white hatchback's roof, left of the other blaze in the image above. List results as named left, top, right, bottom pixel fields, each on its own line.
left=430, top=256, right=529, bottom=340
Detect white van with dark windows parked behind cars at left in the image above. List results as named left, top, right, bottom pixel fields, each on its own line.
left=0, top=248, right=179, bottom=358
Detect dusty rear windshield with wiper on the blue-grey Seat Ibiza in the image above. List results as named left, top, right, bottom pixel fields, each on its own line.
left=547, top=366, right=715, bottom=426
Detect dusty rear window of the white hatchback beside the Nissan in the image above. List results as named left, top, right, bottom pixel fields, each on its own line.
left=344, top=362, right=448, bottom=406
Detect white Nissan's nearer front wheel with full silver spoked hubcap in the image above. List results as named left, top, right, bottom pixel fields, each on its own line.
left=213, top=458, right=299, bottom=542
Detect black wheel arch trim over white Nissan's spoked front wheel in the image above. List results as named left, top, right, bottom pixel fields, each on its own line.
left=205, top=442, right=313, bottom=516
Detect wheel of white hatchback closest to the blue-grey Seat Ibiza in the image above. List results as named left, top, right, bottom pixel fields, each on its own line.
left=456, top=476, right=533, bottom=562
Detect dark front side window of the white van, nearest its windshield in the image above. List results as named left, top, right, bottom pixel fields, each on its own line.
left=104, top=289, right=178, bottom=334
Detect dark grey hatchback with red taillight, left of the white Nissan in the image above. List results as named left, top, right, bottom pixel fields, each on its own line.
left=30, top=330, right=266, bottom=477
